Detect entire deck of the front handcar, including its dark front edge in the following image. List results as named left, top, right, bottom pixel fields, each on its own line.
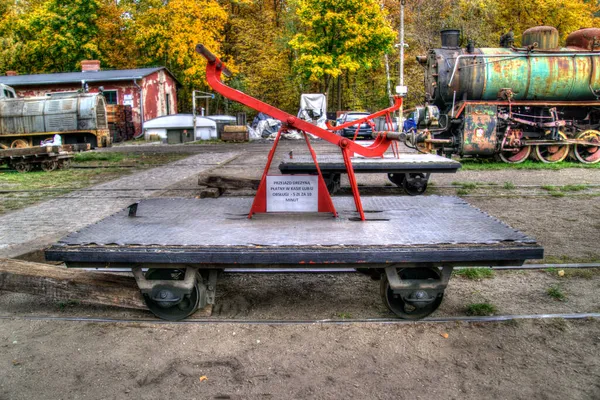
left=46, top=196, right=543, bottom=268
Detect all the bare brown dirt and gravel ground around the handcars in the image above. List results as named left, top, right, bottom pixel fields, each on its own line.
left=0, top=142, right=600, bottom=399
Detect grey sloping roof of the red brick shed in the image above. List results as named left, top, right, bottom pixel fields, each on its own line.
left=0, top=67, right=180, bottom=86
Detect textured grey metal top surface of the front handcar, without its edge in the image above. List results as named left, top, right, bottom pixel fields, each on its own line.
left=58, top=196, right=535, bottom=249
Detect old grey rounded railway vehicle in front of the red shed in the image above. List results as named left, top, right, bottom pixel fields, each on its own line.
left=0, top=85, right=110, bottom=149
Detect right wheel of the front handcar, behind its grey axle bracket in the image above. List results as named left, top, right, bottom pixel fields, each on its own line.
left=380, top=268, right=444, bottom=319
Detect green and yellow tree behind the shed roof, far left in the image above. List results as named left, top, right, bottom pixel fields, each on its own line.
left=0, top=0, right=135, bottom=73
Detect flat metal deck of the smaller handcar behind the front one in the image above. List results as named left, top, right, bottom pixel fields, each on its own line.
left=279, top=153, right=461, bottom=174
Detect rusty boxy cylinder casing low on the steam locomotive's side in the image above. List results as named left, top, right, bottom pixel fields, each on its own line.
left=461, top=104, right=498, bottom=155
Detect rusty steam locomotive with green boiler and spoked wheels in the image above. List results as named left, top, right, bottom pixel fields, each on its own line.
left=413, top=26, right=600, bottom=164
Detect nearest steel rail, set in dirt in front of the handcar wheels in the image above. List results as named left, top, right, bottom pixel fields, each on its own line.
left=0, top=313, right=600, bottom=325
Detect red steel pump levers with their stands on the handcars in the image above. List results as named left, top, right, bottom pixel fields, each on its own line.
left=196, top=44, right=402, bottom=221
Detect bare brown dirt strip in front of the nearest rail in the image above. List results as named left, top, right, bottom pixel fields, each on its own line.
left=0, top=320, right=600, bottom=399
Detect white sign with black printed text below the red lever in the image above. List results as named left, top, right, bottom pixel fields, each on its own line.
left=267, top=175, right=319, bottom=212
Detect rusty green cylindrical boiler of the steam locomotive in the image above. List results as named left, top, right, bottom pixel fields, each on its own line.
left=425, top=48, right=600, bottom=109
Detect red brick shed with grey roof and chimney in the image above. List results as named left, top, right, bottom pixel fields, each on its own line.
left=0, top=60, right=180, bottom=136
